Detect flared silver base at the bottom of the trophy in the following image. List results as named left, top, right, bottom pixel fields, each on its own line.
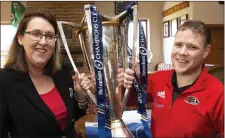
left=111, top=119, right=134, bottom=138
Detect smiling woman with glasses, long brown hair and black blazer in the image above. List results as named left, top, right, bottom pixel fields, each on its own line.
left=0, top=12, right=92, bottom=138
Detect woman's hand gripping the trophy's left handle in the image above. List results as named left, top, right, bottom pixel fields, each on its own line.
left=72, top=73, right=93, bottom=102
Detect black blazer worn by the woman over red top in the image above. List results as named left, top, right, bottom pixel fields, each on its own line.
left=0, top=67, right=85, bottom=138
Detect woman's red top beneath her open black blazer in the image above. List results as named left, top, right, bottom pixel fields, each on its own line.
left=40, top=87, right=68, bottom=130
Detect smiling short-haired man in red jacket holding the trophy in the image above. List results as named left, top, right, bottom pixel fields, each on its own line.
left=122, top=20, right=224, bottom=138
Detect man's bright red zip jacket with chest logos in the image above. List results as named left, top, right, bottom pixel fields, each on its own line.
left=128, top=67, right=224, bottom=138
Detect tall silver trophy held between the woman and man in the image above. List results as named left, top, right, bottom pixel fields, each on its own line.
left=58, top=5, right=138, bottom=137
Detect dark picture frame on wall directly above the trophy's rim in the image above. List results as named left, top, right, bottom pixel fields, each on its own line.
left=115, top=1, right=138, bottom=15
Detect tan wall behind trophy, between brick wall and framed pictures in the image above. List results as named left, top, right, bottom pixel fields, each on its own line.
left=95, top=1, right=163, bottom=71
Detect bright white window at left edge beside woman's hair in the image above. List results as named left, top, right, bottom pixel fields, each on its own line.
left=0, top=24, right=17, bottom=68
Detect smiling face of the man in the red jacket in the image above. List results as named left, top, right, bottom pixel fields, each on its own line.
left=171, top=29, right=211, bottom=74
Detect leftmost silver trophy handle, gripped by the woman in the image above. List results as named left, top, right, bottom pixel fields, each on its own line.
left=57, top=21, right=97, bottom=104
